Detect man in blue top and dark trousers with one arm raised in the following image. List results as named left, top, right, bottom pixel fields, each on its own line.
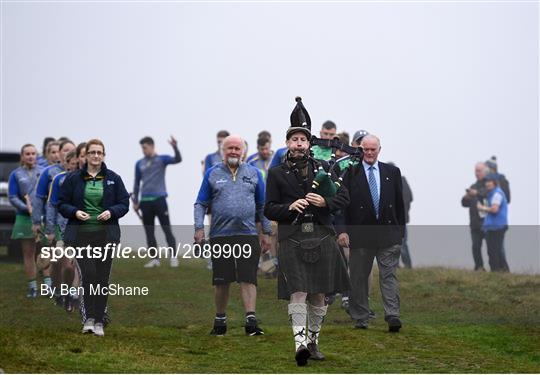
left=133, top=137, right=182, bottom=268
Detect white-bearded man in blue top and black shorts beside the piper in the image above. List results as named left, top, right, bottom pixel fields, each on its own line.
left=194, top=136, right=271, bottom=336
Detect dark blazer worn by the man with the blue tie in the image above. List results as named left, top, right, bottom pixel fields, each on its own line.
left=336, top=162, right=405, bottom=249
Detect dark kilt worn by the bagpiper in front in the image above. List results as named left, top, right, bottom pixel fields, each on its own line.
left=278, top=226, right=351, bottom=300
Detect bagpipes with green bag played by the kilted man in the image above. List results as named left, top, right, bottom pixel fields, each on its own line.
left=291, top=97, right=364, bottom=225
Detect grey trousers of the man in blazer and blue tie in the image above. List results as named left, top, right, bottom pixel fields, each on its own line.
left=349, top=245, right=401, bottom=322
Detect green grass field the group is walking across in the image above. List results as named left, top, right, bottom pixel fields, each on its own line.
left=0, top=261, right=540, bottom=373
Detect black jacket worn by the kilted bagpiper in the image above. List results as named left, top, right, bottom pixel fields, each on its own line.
left=264, top=163, right=349, bottom=241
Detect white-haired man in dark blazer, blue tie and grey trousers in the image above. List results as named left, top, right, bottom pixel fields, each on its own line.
left=338, top=135, right=405, bottom=332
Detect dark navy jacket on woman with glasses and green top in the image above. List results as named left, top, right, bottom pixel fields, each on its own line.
left=58, top=163, right=129, bottom=246
